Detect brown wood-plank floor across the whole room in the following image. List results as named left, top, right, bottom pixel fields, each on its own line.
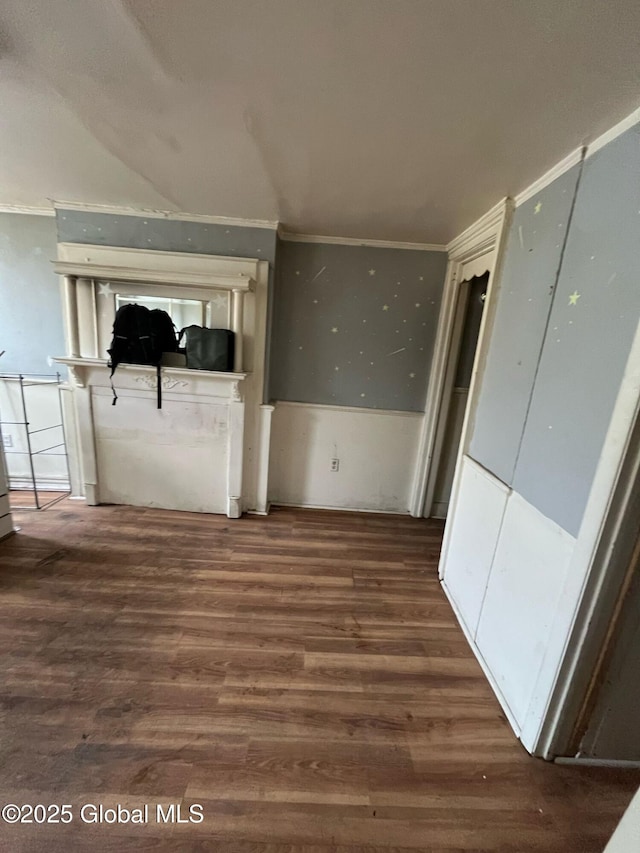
left=0, top=500, right=640, bottom=853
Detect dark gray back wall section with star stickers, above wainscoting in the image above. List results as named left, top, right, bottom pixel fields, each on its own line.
left=271, top=242, right=447, bottom=412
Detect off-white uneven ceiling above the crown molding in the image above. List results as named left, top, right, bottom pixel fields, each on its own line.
left=0, top=0, right=640, bottom=242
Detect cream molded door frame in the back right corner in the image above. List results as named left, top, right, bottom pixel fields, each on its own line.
left=410, top=198, right=513, bottom=518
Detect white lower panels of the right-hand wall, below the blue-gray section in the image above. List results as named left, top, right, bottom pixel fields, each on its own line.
left=440, top=456, right=576, bottom=740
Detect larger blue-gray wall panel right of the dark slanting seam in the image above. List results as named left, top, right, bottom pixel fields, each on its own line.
left=513, top=125, right=640, bottom=536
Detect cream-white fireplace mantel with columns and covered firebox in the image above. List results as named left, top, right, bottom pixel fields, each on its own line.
left=54, top=243, right=270, bottom=518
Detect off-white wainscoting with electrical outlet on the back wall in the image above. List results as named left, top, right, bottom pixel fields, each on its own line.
left=269, top=402, right=423, bottom=513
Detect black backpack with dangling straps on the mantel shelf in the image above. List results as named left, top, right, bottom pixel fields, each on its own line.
left=107, top=304, right=178, bottom=409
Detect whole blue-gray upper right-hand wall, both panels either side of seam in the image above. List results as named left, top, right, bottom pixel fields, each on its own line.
left=470, top=121, right=640, bottom=535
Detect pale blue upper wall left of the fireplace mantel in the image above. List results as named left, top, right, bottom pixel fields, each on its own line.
left=0, top=213, right=65, bottom=374
